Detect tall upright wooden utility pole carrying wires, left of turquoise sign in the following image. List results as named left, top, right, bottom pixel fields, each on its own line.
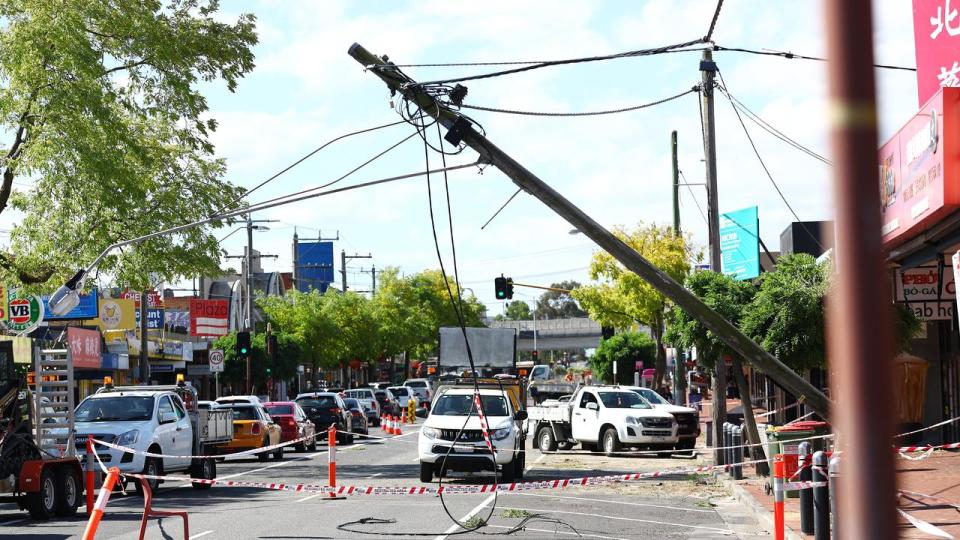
left=700, top=50, right=724, bottom=465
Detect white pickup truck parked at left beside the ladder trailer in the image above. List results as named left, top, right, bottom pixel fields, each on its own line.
left=75, top=385, right=233, bottom=492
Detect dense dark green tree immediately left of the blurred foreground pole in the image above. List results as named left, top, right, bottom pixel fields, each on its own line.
left=741, top=253, right=829, bottom=372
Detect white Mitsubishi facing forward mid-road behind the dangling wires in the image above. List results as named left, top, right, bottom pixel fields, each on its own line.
left=417, top=388, right=527, bottom=483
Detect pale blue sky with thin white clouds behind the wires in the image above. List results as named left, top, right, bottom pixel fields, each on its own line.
left=30, top=0, right=917, bottom=315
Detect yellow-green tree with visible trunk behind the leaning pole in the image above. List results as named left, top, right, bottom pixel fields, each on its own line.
left=573, top=223, right=694, bottom=387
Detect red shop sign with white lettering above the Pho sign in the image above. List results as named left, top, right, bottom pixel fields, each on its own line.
left=878, top=88, right=960, bottom=249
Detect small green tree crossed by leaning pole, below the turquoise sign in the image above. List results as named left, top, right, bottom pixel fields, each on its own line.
left=665, top=271, right=756, bottom=369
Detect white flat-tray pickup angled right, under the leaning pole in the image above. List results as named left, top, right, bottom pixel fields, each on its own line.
left=527, top=386, right=678, bottom=456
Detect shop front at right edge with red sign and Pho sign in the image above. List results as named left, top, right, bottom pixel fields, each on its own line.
left=878, top=88, right=960, bottom=443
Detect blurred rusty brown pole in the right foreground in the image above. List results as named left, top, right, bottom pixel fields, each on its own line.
left=822, top=0, right=899, bottom=540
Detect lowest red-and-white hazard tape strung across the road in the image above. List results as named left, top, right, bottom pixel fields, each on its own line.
left=124, top=460, right=765, bottom=496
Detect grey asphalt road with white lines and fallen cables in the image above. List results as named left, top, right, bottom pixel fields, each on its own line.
left=0, top=422, right=768, bottom=540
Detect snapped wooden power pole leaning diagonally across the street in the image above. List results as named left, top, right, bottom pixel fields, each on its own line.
left=348, top=43, right=830, bottom=417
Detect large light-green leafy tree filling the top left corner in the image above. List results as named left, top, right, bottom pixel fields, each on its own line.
left=0, top=0, right=257, bottom=288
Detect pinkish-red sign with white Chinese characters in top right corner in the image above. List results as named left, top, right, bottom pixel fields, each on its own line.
left=913, top=0, right=960, bottom=105
